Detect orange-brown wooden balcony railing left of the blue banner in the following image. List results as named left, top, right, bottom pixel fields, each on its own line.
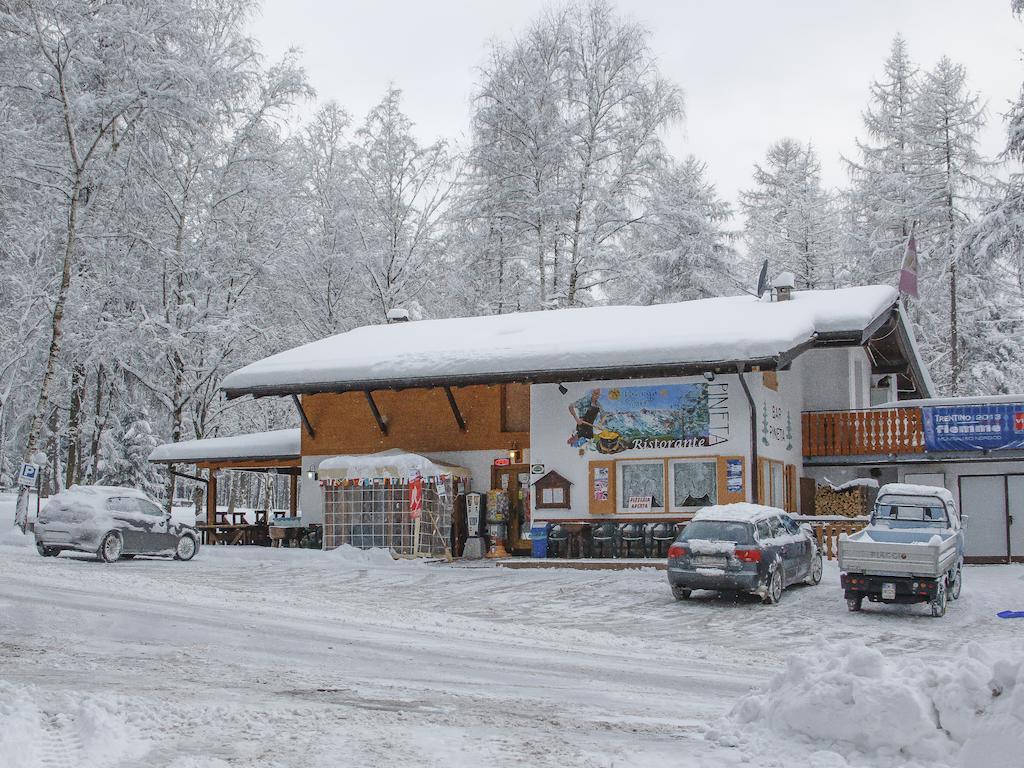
left=803, top=408, right=925, bottom=457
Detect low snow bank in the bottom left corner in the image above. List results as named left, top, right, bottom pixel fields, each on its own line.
left=0, top=680, right=161, bottom=768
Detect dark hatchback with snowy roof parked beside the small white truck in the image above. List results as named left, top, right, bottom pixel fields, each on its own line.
left=668, top=503, right=821, bottom=603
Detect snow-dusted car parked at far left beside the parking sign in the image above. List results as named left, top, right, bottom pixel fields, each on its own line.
left=35, top=485, right=199, bottom=562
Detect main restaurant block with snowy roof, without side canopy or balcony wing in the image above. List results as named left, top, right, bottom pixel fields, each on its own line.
left=207, top=286, right=933, bottom=548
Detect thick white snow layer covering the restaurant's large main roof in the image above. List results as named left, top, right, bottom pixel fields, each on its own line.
left=222, top=286, right=898, bottom=397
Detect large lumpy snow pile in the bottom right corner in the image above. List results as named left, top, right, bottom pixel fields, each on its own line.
left=709, top=642, right=1024, bottom=768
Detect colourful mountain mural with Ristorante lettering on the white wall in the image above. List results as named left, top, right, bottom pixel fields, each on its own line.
left=568, top=383, right=729, bottom=454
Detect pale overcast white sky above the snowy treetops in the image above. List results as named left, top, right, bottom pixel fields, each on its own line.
left=251, top=0, right=1024, bottom=210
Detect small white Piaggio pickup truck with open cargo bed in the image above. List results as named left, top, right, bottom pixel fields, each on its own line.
left=839, top=483, right=967, bottom=616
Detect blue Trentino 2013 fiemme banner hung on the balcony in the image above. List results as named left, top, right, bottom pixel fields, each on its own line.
left=921, top=402, right=1024, bottom=451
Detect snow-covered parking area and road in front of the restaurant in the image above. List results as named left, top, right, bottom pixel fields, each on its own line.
left=0, top=497, right=1024, bottom=768
